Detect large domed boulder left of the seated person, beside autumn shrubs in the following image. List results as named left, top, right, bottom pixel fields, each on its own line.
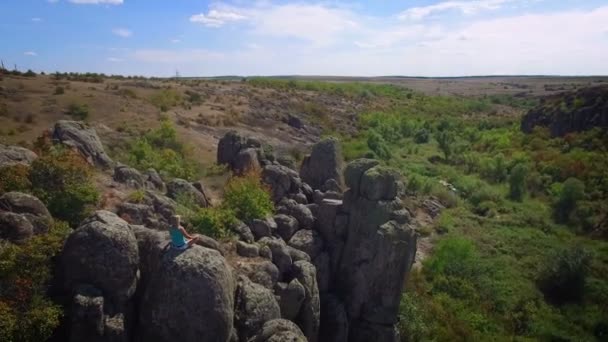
left=61, top=211, right=139, bottom=303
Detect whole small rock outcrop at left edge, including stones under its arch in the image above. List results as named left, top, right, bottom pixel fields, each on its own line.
left=0, top=192, right=53, bottom=238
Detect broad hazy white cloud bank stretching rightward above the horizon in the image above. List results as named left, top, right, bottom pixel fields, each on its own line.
left=147, top=5, right=608, bottom=76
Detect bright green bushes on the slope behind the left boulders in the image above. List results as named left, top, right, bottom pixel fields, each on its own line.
left=119, top=120, right=201, bottom=180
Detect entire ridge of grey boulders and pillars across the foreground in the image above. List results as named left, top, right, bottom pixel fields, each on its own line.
left=0, top=123, right=416, bottom=342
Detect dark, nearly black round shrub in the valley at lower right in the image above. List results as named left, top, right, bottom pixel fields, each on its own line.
left=538, top=247, right=590, bottom=304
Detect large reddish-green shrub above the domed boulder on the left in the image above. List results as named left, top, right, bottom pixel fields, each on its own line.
left=30, top=147, right=99, bottom=226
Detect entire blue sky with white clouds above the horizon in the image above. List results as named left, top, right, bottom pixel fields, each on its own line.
left=0, top=0, right=608, bottom=76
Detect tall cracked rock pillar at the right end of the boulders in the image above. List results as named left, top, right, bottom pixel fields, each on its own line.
left=335, top=160, right=416, bottom=341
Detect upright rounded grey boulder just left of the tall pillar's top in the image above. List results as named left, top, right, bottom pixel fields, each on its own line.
left=300, top=138, right=342, bottom=189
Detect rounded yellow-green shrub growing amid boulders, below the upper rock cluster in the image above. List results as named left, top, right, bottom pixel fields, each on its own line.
left=222, top=173, right=274, bottom=222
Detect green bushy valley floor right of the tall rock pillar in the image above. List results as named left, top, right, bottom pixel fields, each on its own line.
left=343, top=87, right=608, bottom=341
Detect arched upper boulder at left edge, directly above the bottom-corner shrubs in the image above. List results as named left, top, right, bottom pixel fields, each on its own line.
left=0, top=192, right=53, bottom=234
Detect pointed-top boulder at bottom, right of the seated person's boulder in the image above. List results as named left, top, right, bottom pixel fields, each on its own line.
left=234, top=276, right=281, bottom=342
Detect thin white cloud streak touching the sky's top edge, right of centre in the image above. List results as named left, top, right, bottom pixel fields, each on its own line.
left=399, top=0, right=514, bottom=20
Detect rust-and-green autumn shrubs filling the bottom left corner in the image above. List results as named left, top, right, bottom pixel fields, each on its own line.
left=0, top=221, right=70, bottom=341
